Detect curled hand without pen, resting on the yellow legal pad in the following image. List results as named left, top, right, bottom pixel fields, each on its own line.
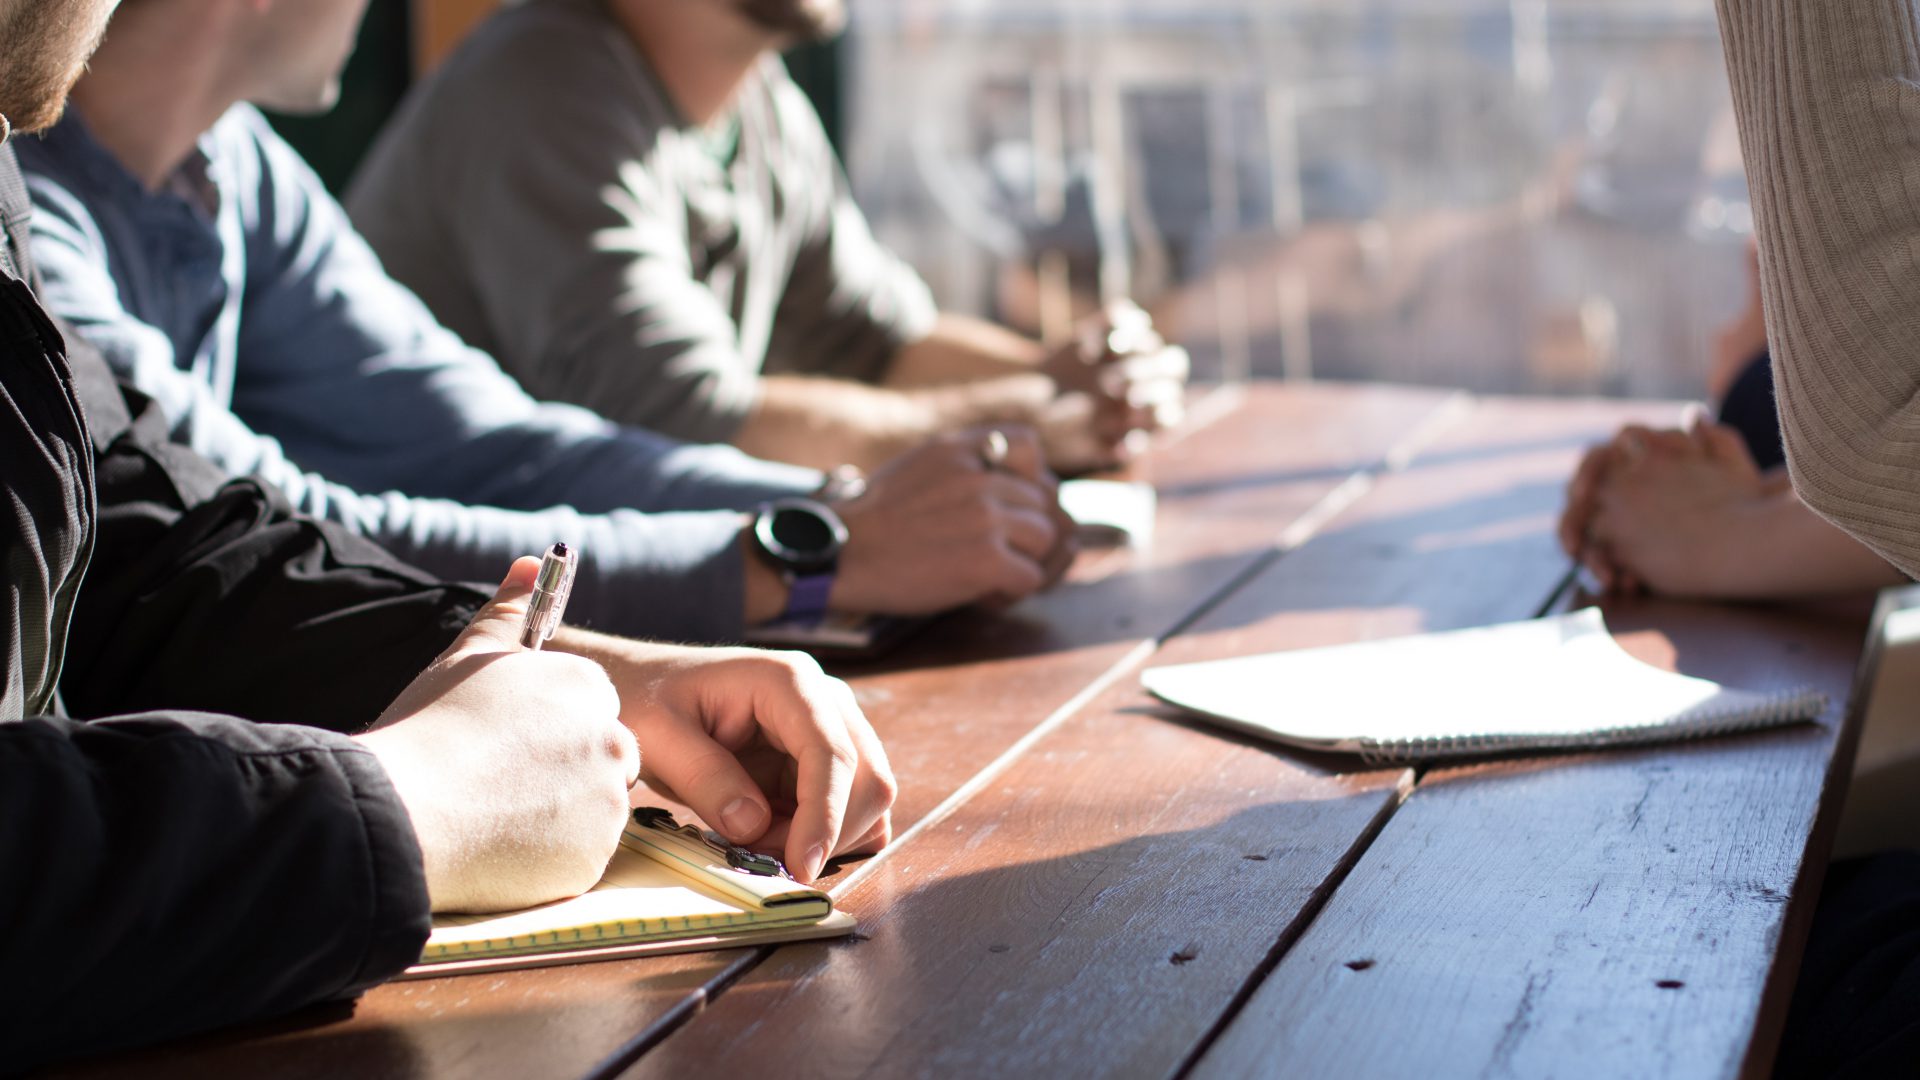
left=559, top=634, right=899, bottom=880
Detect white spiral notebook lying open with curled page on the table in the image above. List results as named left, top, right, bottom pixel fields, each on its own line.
left=1140, top=607, right=1826, bottom=761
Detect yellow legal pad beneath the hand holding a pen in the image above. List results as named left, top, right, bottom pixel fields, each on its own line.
left=407, top=807, right=854, bottom=978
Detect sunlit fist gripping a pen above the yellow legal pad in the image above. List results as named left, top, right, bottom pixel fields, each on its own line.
left=357, top=557, right=639, bottom=911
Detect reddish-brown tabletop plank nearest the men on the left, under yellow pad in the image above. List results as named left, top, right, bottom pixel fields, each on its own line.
left=63, top=386, right=1448, bottom=1076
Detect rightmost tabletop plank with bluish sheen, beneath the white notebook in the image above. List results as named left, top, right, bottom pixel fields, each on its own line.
left=1194, top=601, right=1864, bottom=1080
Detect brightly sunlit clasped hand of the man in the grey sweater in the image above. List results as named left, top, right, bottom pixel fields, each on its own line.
left=1039, top=302, right=1192, bottom=471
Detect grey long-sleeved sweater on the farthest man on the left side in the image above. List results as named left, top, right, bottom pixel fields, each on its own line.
left=348, top=0, right=935, bottom=442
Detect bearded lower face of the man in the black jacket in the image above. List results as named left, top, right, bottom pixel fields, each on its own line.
left=0, top=0, right=115, bottom=131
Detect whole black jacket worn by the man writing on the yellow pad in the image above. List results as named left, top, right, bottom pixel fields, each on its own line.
left=0, top=146, right=472, bottom=1074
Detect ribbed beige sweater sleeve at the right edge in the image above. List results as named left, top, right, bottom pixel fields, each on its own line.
left=1716, top=0, right=1920, bottom=575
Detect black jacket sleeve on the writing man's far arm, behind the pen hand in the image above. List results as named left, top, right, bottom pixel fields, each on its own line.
left=60, top=342, right=487, bottom=732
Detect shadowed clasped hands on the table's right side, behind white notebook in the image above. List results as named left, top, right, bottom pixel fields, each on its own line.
left=1586, top=419, right=1770, bottom=596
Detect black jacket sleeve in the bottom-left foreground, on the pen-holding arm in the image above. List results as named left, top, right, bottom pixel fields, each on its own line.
left=0, top=713, right=428, bottom=1072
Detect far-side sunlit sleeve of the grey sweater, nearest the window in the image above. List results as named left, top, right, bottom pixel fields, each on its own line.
left=768, top=73, right=937, bottom=382
